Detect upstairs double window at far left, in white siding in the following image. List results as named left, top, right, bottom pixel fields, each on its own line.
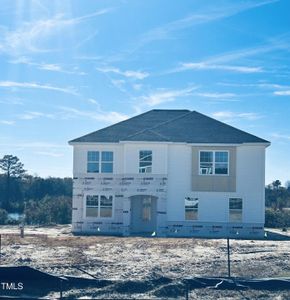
left=87, top=151, right=114, bottom=173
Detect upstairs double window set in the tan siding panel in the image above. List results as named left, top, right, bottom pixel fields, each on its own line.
left=199, top=151, right=229, bottom=175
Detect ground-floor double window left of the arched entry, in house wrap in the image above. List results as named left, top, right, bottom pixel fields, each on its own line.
left=86, top=195, right=113, bottom=218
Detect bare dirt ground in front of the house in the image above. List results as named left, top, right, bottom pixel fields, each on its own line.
left=0, top=226, right=290, bottom=300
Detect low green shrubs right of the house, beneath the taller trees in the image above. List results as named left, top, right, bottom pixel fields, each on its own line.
left=265, top=209, right=290, bottom=228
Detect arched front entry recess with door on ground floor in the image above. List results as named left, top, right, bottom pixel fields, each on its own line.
left=130, top=195, right=157, bottom=234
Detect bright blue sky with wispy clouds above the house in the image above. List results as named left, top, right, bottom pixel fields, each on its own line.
left=0, top=0, right=290, bottom=183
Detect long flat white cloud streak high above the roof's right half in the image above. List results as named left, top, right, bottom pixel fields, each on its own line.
left=177, top=62, right=263, bottom=73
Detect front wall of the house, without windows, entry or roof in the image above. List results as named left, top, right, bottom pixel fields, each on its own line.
left=73, top=143, right=265, bottom=238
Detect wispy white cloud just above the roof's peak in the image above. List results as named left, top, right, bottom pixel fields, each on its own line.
left=139, top=87, right=197, bottom=106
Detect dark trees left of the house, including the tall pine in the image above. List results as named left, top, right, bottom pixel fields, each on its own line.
left=0, top=155, right=72, bottom=224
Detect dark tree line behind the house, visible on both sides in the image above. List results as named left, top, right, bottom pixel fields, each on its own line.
left=0, top=155, right=290, bottom=227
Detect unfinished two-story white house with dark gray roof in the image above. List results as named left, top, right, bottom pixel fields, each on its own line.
left=69, top=110, right=270, bottom=237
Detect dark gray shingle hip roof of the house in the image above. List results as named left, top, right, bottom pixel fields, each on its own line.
left=70, top=109, right=269, bottom=144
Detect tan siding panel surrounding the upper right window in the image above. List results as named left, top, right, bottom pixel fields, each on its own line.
left=192, top=146, right=237, bottom=192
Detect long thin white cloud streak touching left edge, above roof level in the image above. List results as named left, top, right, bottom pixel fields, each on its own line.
left=0, top=81, right=79, bottom=96
